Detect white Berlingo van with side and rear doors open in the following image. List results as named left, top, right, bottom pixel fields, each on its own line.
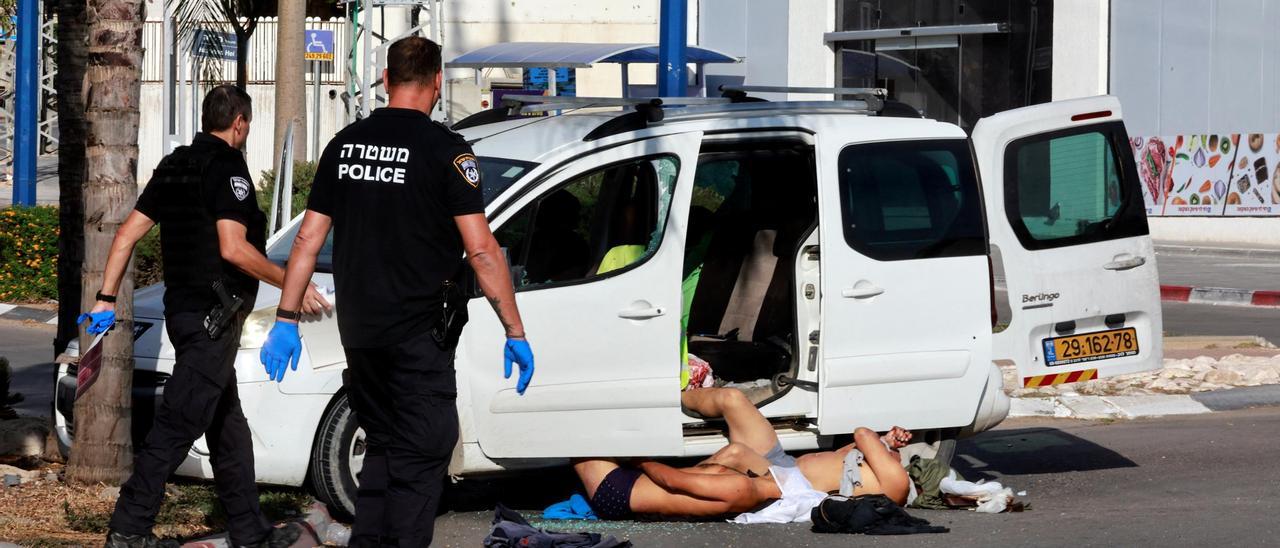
left=56, top=92, right=1162, bottom=511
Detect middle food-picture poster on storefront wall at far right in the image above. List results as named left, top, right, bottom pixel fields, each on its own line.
left=1160, top=133, right=1240, bottom=216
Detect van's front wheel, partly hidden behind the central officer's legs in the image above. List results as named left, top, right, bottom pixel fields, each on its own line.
left=308, top=393, right=365, bottom=520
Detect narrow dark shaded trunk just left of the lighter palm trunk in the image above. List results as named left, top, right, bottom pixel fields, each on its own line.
left=54, top=0, right=88, bottom=353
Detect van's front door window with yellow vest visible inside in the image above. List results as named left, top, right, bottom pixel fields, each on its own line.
left=494, top=156, right=678, bottom=289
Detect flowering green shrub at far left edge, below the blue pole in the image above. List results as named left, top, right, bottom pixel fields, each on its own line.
left=0, top=206, right=58, bottom=302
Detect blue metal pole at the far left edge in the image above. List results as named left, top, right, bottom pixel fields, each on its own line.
left=13, top=0, right=40, bottom=206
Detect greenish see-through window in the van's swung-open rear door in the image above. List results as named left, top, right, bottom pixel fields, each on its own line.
left=1005, top=124, right=1147, bottom=250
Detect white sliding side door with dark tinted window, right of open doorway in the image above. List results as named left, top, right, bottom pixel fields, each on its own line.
left=818, top=120, right=991, bottom=435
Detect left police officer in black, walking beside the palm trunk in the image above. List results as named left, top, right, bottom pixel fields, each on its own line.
left=82, top=86, right=329, bottom=547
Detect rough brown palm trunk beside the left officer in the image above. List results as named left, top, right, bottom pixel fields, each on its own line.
left=67, top=0, right=143, bottom=484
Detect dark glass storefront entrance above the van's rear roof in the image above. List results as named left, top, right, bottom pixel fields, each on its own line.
left=835, top=0, right=1053, bottom=128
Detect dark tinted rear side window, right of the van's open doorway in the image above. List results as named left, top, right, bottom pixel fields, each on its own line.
left=838, top=140, right=987, bottom=261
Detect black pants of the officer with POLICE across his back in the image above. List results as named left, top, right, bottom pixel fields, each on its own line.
left=346, top=333, right=458, bottom=547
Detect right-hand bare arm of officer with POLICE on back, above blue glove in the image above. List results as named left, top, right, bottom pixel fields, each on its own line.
left=455, top=211, right=525, bottom=339
